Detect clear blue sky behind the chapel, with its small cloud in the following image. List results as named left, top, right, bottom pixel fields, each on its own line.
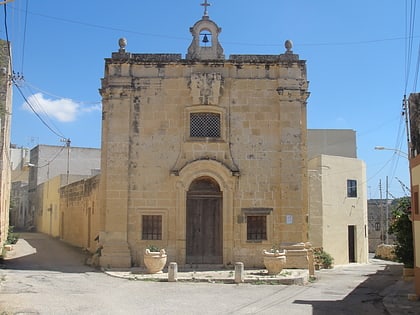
left=0, top=0, right=419, bottom=198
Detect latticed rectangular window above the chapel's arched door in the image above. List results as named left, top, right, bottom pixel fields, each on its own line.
left=190, top=113, right=220, bottom=138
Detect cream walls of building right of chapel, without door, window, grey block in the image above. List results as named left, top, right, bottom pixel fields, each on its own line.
left=308, top=155, right=368, bottom=265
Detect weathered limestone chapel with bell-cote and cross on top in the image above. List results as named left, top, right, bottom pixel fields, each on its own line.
left=99, top=2, right=309, bottom=267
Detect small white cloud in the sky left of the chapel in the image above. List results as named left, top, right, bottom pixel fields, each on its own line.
left=22, top=93, right=101, bottom=122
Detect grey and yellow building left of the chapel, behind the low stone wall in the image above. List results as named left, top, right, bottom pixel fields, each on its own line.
left=25, top=143, right=101, bottom=232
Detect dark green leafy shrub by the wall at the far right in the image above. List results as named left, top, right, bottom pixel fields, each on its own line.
left=388, top=197, right=414, bottom=275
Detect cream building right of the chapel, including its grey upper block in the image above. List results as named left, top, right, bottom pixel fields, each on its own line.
left=308, top=129, right=368, bottom=265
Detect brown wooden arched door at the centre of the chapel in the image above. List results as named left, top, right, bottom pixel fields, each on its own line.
left=186, top=177, right=223, bottom=264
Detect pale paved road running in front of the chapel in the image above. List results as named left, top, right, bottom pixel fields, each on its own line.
left=0, top=233, right=409, bottom=315
